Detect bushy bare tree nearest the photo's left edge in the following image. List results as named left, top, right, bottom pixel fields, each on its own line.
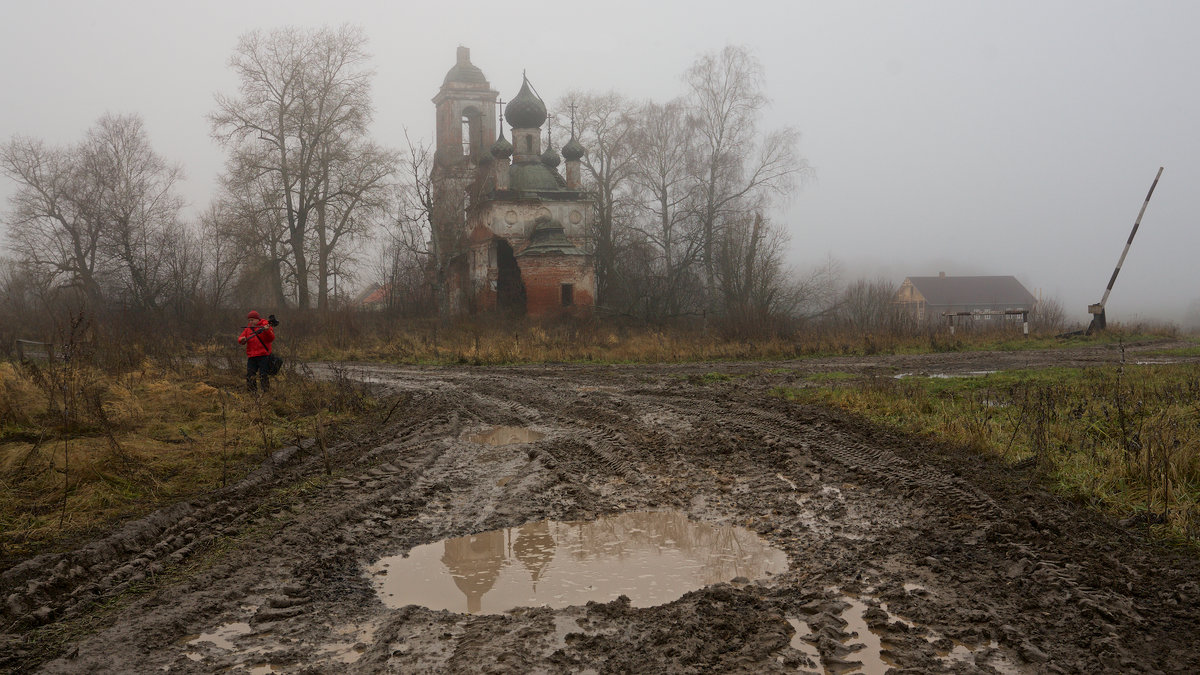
left=0, top=115, right=182, bottom=310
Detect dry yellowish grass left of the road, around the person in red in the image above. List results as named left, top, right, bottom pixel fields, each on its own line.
left=0, top=359, right=372, bottom=557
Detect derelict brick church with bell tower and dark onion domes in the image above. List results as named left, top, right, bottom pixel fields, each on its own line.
left=431, top=47, right=595, bottom=317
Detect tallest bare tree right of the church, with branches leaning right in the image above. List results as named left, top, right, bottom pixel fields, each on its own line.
left=684, top=46, right=809, bottom=311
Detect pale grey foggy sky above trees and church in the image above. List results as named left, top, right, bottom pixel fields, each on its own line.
left=0, top=0, right=1200, bottom=321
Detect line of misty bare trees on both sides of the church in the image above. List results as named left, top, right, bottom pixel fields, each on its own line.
left=0, top=26, right=1070, bottom=344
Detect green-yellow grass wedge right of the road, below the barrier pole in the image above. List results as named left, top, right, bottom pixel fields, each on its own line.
left=773, top=364, right=1200, bottom=542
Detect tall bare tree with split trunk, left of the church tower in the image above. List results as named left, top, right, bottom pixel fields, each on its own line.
left=210, top=26, right=385, bottom=309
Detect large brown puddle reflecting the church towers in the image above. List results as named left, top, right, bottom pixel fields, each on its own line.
left=367, top=510, right=787, bottom=614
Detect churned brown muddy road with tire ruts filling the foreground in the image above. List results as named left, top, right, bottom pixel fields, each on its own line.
left=0, top=346, right=1200, bottom=673
